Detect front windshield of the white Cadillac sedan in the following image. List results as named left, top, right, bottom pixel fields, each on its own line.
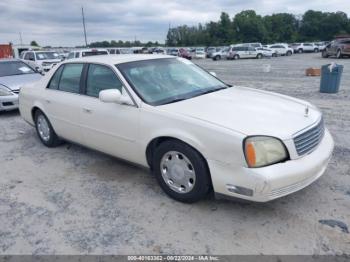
left=116, top=58, right=228, bottom=106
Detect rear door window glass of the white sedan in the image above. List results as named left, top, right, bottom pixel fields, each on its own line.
left=58, top=64, right=84, bottom=94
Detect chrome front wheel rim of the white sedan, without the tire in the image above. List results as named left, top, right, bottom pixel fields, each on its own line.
left=160, top=151, right=196, bottom=193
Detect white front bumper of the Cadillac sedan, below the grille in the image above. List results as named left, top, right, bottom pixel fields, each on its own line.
left=208, top=130, right=334, bottom=202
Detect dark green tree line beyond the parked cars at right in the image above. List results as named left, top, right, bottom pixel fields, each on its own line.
left=166, top=10, right=350, bottom=46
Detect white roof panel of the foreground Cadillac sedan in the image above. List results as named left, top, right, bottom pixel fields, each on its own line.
left=64, top=54, right=175, bottom=65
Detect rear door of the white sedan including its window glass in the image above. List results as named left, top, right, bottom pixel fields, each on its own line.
left=43, top=63, right=84, bottom=143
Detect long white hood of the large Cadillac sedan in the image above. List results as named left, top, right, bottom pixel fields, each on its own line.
left=160, top=86, right=321, bottom=139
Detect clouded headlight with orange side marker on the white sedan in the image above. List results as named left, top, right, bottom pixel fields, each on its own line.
left=243, top=136, right=289, bottom=167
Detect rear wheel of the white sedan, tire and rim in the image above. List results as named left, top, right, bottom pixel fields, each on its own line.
left=34, top=110, right=62, bottom=147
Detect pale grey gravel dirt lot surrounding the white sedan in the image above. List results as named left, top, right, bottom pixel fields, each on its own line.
left=0, top=54, right=350, bottom=254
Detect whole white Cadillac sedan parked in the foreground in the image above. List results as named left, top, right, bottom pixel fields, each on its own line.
left=20, top=55, right=333, bottom=202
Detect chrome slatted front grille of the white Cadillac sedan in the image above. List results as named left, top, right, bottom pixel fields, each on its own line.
left=293, top=118, right=324, bottom=156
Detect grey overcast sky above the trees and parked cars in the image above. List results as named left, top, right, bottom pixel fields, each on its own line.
left=0, top=0, right=350, bottom=46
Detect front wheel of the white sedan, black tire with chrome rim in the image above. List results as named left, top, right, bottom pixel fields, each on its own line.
left=152, top=140, right=211, bottom=203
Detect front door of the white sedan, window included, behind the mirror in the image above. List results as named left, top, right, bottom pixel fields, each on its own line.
left=80, top=64, right=139, bottom=161
